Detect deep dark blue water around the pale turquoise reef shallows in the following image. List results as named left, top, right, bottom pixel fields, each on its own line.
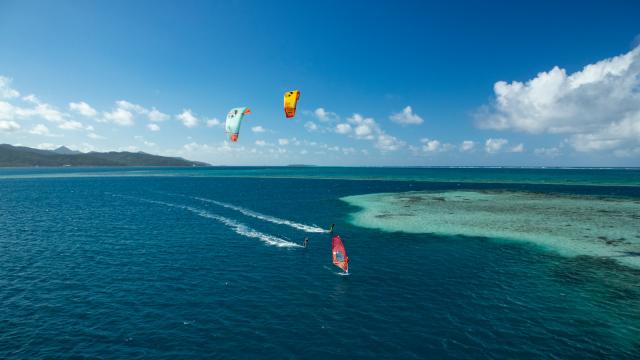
left=0, top=170, right=640, bottom=359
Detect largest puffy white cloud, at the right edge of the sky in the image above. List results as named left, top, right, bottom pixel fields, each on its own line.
left=477, top=47, right=640, bottom=152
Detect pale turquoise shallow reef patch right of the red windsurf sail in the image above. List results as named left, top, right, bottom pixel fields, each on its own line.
left=343, top=190, right=640, bottom=269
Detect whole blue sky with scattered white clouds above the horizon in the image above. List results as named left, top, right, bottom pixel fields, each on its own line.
left=0, top=0, right=640, bottom=166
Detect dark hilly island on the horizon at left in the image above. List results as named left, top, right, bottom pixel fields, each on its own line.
left=0, top=144, right=209, bottom=167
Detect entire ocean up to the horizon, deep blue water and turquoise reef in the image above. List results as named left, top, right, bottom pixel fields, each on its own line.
left=0, top=167, right=640, bottom=359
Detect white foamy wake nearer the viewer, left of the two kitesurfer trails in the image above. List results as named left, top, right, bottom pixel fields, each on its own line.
left=116, top=195, right=302, bottom=248
